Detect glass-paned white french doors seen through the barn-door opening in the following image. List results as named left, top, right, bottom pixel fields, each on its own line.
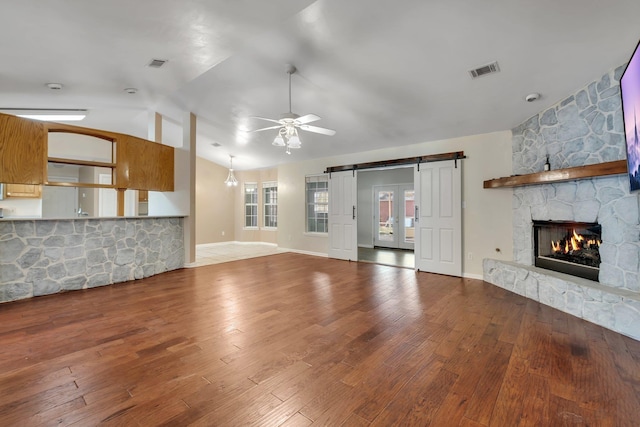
left=373, top=184, right=415, bottom=249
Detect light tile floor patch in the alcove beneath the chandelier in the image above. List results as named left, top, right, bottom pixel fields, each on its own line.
left=185, top=242, right=287, bottom=267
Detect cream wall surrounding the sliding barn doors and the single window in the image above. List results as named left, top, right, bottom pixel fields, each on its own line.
left=278, top=131, right=513, bottom=279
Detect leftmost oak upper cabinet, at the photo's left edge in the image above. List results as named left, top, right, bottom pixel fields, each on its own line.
left=0, top=114, right=47, bottom=184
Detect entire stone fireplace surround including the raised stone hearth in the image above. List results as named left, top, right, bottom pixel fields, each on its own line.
left=483, top=62, right=640, bottom=340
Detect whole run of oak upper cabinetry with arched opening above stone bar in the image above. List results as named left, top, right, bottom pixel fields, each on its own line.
left=0, top=114, right=174, bottom=191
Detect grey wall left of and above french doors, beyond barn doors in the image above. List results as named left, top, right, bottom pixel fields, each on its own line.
left=358, top=167, right=413, bottom=247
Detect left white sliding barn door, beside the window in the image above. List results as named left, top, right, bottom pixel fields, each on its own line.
left=329, top=171, right=358, bottom=261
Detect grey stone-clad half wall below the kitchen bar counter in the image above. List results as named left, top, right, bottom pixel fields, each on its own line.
left=0, top=217, right=184, bottom=302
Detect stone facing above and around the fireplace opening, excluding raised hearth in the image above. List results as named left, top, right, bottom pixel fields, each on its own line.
left=512, top=66, right=640, bottom=293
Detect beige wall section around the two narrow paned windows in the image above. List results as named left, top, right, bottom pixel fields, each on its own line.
left=235, top=168, right=281, bottom=243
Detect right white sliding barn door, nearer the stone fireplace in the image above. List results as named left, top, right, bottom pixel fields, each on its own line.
left=414, top=160, right=462, bottom=276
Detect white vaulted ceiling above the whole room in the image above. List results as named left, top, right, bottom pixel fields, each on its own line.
left=0, top=0, right=640, bottom=169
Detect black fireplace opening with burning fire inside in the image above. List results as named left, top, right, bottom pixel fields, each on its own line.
left=533, top=221, right=602, bottom=282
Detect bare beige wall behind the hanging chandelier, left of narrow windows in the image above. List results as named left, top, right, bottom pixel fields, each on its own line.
left=196, top=157, right=240, bottom=245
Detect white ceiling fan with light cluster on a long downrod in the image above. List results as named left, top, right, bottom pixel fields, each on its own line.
left=251, top=64, right=336, bottom=154
